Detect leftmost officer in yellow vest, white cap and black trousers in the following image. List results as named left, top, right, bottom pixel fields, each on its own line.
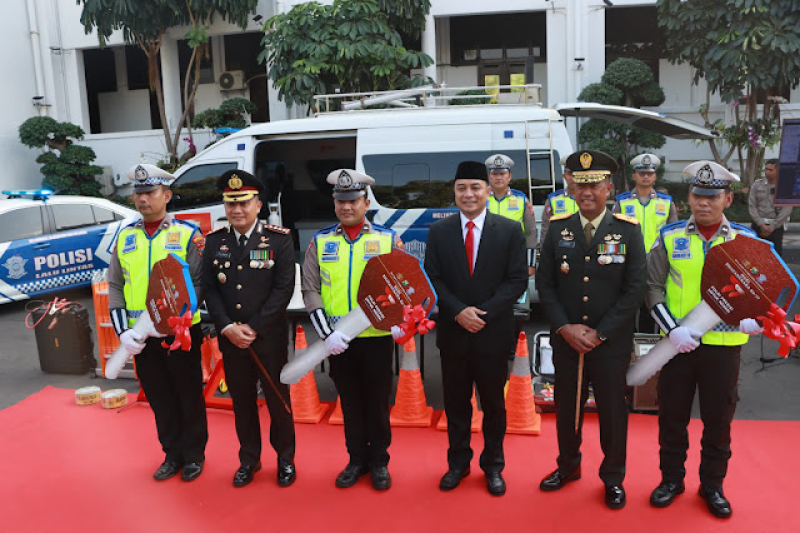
left=108, top=164, right=208, bottom=481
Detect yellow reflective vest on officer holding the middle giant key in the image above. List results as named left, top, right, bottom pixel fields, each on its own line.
left=314, top=224, right=394, bottom=337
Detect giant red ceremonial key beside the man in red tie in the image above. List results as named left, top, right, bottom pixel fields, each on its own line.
left=281, top=249, right=436, bottom=384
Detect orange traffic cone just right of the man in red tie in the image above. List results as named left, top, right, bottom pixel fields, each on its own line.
left=506, top=331, right=542, bottom=435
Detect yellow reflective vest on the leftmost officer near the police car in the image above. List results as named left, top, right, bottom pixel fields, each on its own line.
left=117, top=219, right=200, bottom=327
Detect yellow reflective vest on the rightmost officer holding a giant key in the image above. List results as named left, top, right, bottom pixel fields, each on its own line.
left=661, top=220, right=752, bottom=346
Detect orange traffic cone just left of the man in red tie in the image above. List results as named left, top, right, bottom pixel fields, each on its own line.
left=389, top=337, right=433, bottom=428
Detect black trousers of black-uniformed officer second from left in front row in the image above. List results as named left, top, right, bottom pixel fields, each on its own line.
left=219, top=335, right=295, bottom=466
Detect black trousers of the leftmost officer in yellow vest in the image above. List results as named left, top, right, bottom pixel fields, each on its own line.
left=136, top=324, right=208, bottom=464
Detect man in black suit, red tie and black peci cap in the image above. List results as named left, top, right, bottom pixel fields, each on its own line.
left=425, top=161, right=528, bottom=496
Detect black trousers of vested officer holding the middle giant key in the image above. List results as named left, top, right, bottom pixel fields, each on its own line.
left=329, top=335, right=394, bottom=467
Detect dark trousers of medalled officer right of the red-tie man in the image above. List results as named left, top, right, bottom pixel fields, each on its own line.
left=551, top=335, right=631, bottom=485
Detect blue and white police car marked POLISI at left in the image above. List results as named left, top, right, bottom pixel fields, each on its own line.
left=0, top=189, right=137, bottom=303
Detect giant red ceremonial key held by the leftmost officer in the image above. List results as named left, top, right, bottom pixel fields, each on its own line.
left=105, top=254, right=197, bottom=379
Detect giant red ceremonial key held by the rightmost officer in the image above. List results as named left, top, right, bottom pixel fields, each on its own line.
left=627, top=234, right=798, bottom=386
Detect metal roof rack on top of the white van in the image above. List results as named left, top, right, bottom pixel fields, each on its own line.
left=314, top=84, right=542, bottom=114
